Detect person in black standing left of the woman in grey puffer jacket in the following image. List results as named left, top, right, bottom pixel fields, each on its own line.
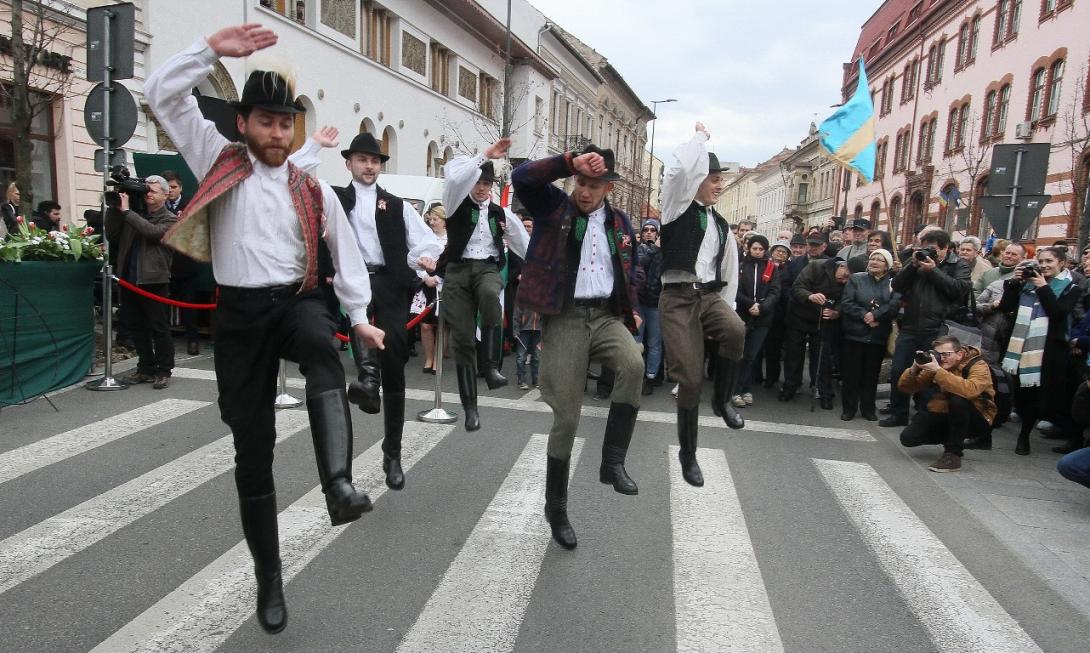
left=779, top=258, right=850, bottom=410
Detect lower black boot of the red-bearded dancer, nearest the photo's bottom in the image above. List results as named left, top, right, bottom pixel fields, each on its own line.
left=239, top=492, right=288, bottom=633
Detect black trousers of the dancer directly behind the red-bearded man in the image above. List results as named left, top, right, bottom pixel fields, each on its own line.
left=368, top=273, right=415, bottom=394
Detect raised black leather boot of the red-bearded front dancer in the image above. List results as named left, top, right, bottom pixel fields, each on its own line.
left=306, top=390, right=372, bottom=527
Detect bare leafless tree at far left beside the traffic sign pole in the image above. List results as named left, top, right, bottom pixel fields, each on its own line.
left=0, top=0, right=76, bottom=216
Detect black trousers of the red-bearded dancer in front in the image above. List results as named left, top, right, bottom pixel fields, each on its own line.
left=215, top=285, right=344, bottom=497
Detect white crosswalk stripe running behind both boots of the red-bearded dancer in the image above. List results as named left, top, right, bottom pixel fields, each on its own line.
left=94, top=422, right=453, bottom=653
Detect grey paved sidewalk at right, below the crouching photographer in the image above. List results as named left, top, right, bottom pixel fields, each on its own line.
left=875, top=424, right=1090, bottom=618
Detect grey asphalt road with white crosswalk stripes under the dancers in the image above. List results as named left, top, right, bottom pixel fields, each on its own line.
left=0, top=356, right=1090, bottom=652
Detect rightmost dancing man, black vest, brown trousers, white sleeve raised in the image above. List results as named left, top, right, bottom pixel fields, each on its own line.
left=658, top=122, right=746, bottom=486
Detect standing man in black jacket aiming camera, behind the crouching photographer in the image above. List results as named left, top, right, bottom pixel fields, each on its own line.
left=879, top=228, right=972, bottom=426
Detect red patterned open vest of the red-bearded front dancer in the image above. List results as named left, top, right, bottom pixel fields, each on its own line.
left=162, top=143, right=323, bottom=292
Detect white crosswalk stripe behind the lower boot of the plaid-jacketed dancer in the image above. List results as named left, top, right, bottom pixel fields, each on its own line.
left=398, top=435, right=583, bottom=653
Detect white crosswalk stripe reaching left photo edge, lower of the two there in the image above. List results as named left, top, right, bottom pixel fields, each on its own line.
left=0, top=410, right=308, bottom=594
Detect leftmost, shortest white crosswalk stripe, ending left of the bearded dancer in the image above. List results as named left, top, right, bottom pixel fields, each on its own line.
left=0, top=399, right=209, bottom=484
